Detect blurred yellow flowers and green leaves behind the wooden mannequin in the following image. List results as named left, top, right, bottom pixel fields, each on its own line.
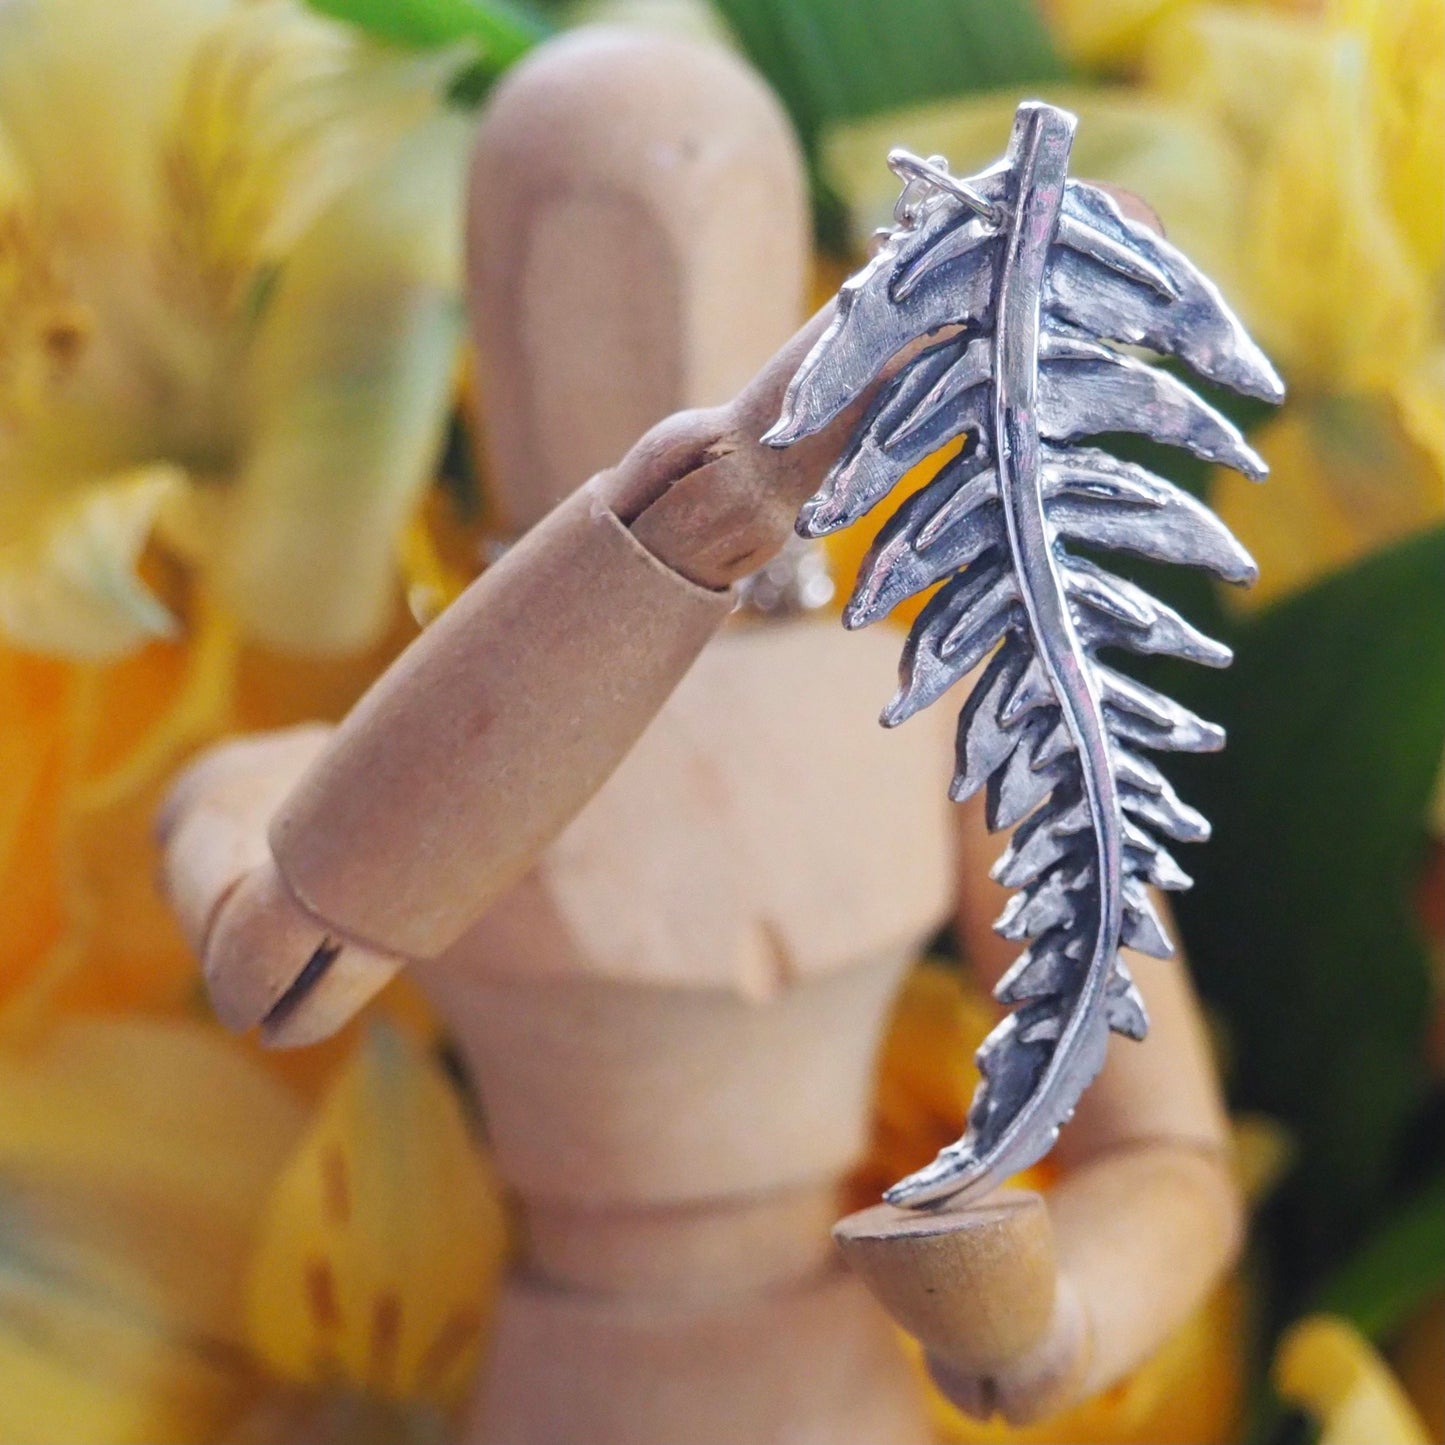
left=0, top=0, right=1445, bottom=1445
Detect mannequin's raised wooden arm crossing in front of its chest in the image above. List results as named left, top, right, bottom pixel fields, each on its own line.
left=162, top=307, right=851, bottom=1043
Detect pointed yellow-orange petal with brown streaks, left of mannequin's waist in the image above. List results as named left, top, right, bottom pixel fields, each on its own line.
left=246, top=1025, right=506, bottom=1405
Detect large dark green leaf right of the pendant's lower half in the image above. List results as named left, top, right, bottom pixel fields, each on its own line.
left=1168, top=529, right=1445, bottom=1279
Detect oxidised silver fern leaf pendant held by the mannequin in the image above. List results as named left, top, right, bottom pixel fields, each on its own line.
left=764, top=103, right=1283, bottom=1207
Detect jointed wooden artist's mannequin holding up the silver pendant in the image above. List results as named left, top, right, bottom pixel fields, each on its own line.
left=163, top=25, right=1234, bottom=1445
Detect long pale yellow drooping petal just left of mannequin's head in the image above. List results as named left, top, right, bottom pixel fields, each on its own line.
left=215, top=116, right=470, bottom=653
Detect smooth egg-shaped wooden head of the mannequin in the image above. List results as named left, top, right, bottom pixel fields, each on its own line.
left=468, top=29, right=809, bottom=533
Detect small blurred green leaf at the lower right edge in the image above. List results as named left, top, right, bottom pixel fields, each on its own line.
left=1314, top=1173, right=1445, bottom=1340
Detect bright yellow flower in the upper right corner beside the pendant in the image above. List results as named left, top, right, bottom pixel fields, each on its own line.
left=1146, top=0, right=1445, bottom=605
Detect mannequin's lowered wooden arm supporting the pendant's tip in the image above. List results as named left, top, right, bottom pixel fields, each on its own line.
left=838, top=799, right=1243, bottom=1423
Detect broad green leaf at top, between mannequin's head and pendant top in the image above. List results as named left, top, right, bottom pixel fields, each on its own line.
left=715, top=0, right=1065, bottom=155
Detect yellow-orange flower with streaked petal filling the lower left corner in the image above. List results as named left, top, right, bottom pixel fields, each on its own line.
left=0, top=1017, right=506, bottom=1445
